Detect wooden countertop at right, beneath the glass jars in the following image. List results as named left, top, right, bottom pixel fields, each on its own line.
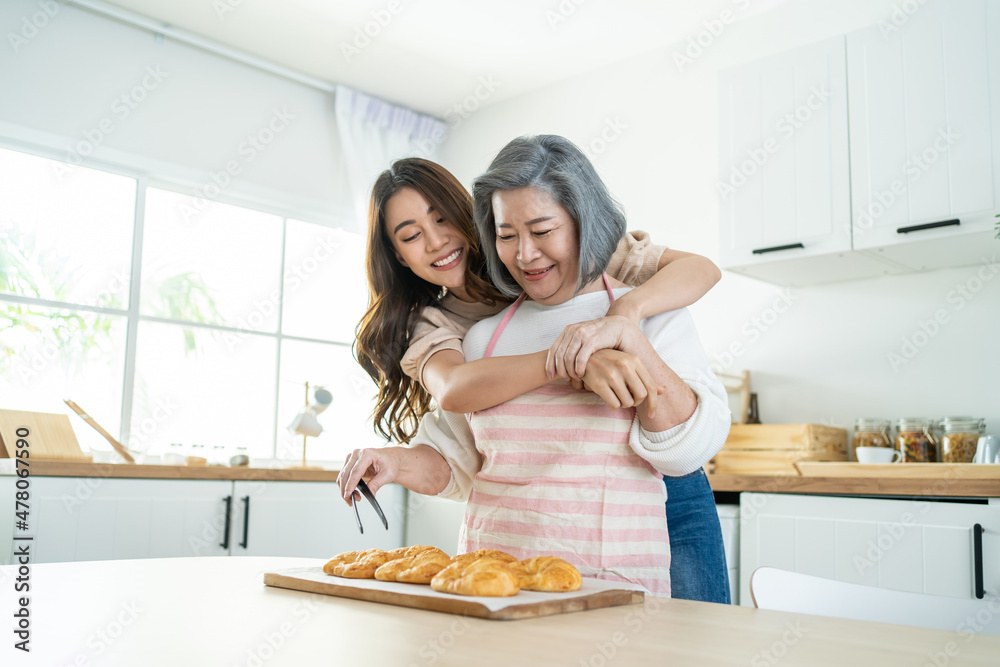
left=708, top=472, right=1000, bottom=498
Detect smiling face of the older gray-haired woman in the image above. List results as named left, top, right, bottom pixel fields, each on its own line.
left=493, top=188, right=580, bottom=306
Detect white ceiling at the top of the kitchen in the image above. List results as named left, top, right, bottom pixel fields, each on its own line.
left=95, top=0, right=787, bottom=118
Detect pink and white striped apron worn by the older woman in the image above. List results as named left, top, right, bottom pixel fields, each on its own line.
left=459, top=276, right=670, bottom=596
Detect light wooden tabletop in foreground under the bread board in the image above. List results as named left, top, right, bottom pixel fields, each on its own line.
left=0, top=558, right=1000, bottom=667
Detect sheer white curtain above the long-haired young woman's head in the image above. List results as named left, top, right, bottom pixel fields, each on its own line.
left=334, top=86, right=447, bottom=229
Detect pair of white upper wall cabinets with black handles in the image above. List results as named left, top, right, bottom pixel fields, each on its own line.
left=718, top=0, right=1000, bottom=285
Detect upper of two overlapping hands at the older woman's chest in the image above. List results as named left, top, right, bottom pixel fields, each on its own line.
left=545, top=315, right=641, bottom=380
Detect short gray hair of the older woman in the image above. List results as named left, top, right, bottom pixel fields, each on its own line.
left=472, top=134, right=625, bottom=296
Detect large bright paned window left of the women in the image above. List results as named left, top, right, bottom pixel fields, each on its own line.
left=0, top=149, right=380, bottom=463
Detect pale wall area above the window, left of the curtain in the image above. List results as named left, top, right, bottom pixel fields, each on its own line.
left=0, top=0, right=352, bottom=226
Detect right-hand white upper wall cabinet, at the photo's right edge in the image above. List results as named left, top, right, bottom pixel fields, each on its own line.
left=847, top=0, right=1000, bottom=269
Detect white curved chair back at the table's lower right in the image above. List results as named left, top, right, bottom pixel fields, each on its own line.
left=750, top=567, right=1000, bottom=635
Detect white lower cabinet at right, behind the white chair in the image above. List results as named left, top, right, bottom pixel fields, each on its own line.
left=740, top=493, right=1000, bottom=605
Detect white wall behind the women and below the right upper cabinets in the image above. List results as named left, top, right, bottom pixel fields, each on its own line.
left=440, top=0, right=1000, bottom=433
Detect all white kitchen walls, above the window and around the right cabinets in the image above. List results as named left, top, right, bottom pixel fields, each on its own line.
left=0, top=0, right=1000, bottom=432
